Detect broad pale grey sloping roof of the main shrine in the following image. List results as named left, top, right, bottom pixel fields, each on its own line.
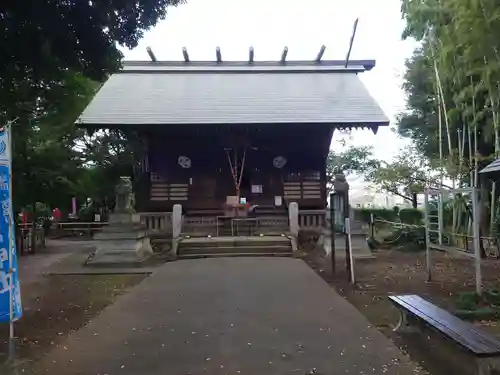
left=77, top=60, right=389, bottom=128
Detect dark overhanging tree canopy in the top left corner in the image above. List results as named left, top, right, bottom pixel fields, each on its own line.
left=0, top=0, right=181, bottom=85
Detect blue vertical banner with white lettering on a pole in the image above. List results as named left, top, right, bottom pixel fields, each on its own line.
left=0, top=124, right=23, bottom=322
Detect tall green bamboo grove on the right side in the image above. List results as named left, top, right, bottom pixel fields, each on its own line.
left=398, top=0, right=500, bottom=241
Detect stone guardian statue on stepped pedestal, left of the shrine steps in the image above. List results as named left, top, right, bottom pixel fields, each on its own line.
left=86, top=177, right=153, bottom=267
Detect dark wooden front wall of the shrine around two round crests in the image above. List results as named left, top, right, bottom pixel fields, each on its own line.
left=138, top=127, right=326, bottom=212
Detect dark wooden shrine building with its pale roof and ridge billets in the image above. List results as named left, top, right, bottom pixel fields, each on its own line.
left=77, top=49, right=389, bottom=223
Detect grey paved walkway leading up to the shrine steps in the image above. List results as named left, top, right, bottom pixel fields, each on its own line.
left=26, top=258, right=415, bottom=375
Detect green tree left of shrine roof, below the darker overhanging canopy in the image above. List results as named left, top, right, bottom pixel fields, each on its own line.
left=12, top=72, right=97, bottom=210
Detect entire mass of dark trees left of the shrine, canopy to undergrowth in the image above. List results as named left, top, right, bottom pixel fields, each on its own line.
left=0, top=0, right=171, bottom=217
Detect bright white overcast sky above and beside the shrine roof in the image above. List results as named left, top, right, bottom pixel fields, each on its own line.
left=124, top=0, right=416, bottom=164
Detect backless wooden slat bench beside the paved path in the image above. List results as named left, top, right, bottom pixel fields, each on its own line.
left=389, top=294, right=500, bottom=375
